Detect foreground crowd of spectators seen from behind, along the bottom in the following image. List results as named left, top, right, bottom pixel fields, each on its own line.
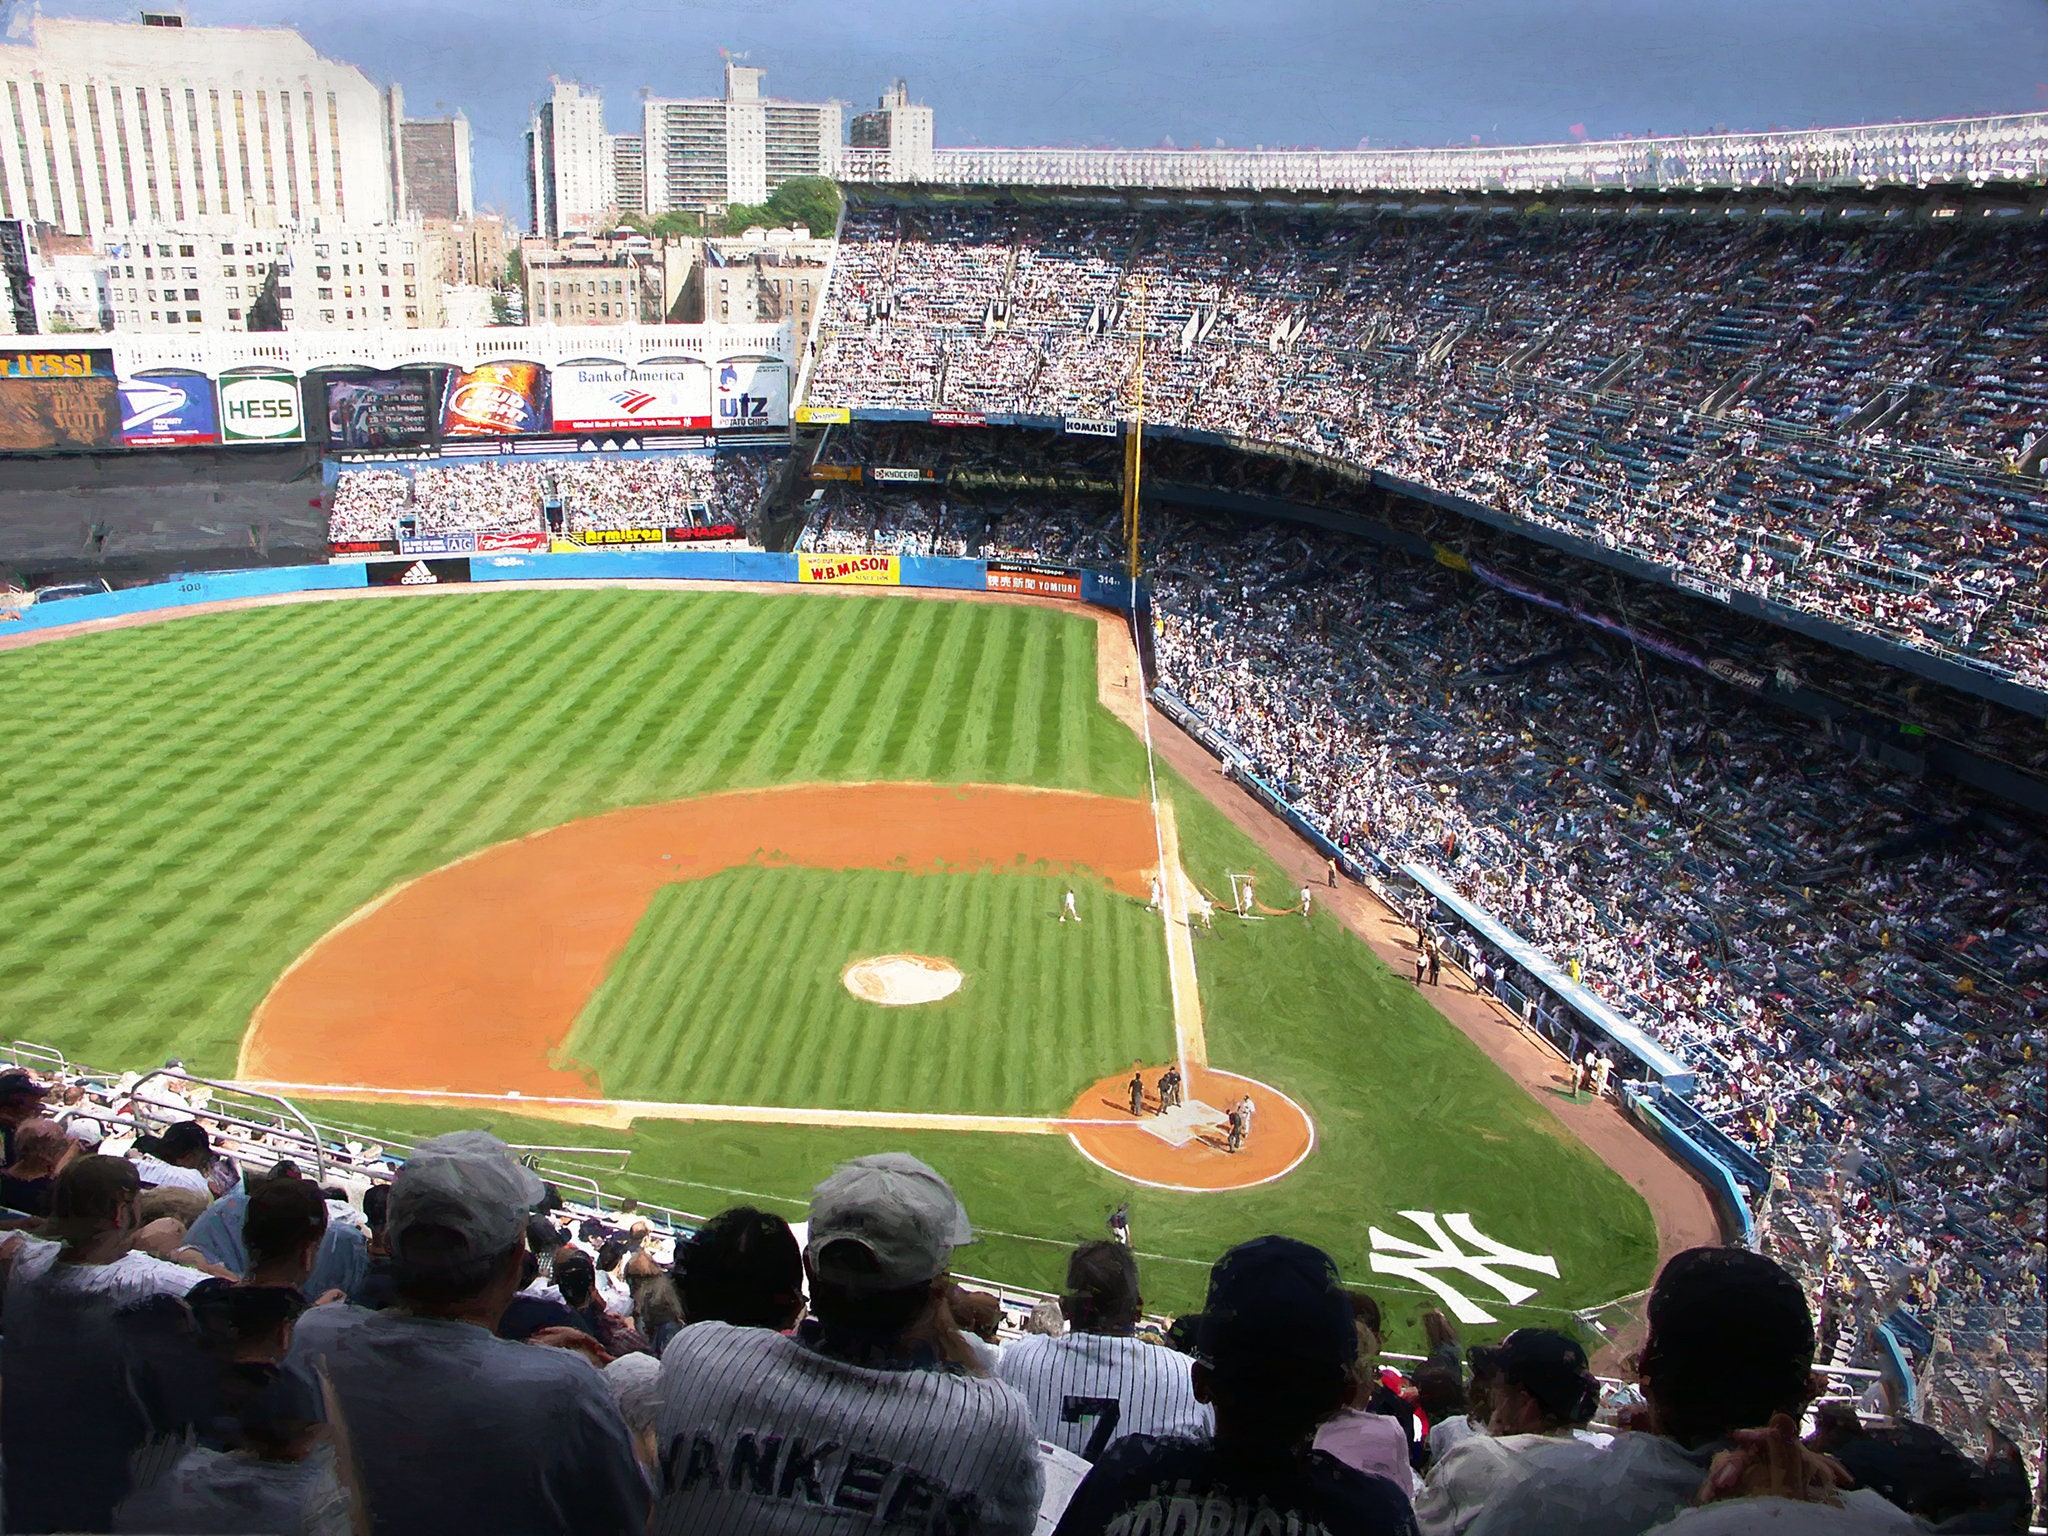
left=0, top=1071, right=2034, bottom=1536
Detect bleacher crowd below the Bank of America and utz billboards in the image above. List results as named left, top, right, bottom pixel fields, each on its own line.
left=328, top=453, right=780, bottom=543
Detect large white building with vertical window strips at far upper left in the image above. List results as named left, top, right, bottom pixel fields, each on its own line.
left=0, top=12, right=393, bottom=240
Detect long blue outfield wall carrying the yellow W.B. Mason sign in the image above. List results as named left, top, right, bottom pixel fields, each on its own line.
left=0, top=549, right=1130, bottom=639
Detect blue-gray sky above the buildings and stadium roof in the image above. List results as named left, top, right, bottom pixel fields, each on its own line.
left=16, top=0, right=2048, bottom=221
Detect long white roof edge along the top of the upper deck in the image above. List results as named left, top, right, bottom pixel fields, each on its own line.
left=840, top=113, right=2048, bottom=195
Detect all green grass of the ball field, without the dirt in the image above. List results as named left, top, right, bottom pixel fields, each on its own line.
left=0, top=590, right=1655, bottom=1337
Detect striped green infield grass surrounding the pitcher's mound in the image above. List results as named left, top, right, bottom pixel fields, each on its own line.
left=563, top=868, right=1174, bottom=1114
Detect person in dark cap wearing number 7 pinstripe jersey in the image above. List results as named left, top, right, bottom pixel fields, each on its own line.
left=995, top=1241, right=1212, bottom=1460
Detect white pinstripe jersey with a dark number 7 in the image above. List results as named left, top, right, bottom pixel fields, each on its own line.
left=995, top=1333, right=1212, bottom=1460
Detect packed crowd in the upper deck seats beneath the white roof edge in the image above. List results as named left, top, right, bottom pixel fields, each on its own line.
left=811, top=209, right=2048, bottom=686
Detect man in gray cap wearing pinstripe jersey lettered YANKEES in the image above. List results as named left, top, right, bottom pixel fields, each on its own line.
left=653, top=1153, right=1042, bottom=1536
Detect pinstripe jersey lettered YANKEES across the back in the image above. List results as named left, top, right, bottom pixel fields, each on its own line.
left=649, top=1323, right=1044, bottom=1536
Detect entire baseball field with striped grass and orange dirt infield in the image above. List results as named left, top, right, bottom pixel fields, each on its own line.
left=0, top=590, right=1657, bottom=1341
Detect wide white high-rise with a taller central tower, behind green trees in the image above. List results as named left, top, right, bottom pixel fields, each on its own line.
left=641, top=61, right=842, bottom=213
